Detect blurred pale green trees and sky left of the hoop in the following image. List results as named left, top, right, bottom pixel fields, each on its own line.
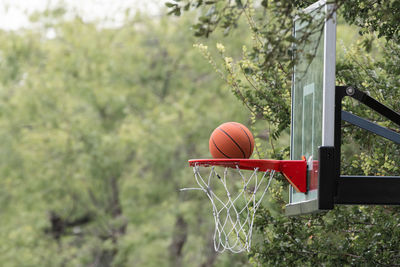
left=0, top=0, right=253, bottom=266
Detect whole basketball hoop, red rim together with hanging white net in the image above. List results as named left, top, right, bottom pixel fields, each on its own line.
left=181, top=159, right=307, bottom=253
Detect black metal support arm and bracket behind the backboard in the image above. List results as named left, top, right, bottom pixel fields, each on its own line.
left=318, top=86, right=400, bottom=210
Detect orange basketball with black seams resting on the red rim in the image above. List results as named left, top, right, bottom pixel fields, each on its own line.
left=209, top=122, right=254, bottom=159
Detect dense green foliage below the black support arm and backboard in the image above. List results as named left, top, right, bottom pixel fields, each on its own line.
left=250, top=206, right=400, bottom=266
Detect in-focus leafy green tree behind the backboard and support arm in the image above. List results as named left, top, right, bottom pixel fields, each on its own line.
left=167, top=0, right=400, bottom=266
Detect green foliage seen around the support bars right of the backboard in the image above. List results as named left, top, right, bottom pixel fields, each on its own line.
left=337, top=41, right=400, bottom=176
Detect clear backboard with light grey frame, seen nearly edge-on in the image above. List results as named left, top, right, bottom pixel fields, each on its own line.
left=286, top=0, right=336, bottom=215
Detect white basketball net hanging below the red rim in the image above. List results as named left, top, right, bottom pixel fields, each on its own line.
left=181, top=165, right=275, bottom=253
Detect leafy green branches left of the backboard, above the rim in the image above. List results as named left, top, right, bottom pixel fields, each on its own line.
left=169, top=1, right=334, bottom=144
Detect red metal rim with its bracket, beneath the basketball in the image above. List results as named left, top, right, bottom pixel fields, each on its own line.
left=189, top=159, right=307, bottom=193
